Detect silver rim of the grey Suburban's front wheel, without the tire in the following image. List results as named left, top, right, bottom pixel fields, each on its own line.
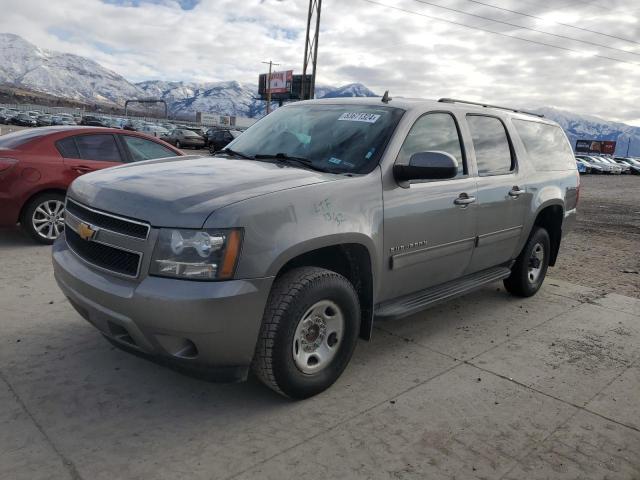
left=292, top=300, right=344, bottom=374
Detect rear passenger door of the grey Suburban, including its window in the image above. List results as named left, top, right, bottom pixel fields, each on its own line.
left=466, top=114, right=532, bottom=273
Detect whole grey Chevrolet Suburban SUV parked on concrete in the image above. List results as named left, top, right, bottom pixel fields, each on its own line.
left=53, top=94, right=579, bottom=398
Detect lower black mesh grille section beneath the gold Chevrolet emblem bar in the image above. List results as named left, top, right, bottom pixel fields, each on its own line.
left=64, top=228, right=141, bottom=277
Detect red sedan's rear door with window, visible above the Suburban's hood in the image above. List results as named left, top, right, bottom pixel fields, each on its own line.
left=56, top=133, right=125, bottom=181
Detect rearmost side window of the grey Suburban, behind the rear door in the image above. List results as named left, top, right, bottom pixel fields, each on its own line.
left=513, top=119, right=575, bottom=171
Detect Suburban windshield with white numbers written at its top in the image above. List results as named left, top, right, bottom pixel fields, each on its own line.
left=228, top=104, right=404, bottom=173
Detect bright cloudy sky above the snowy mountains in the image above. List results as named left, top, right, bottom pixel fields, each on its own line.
left=0, top=0, right=640, bottom=126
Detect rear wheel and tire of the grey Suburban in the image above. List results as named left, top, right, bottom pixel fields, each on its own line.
left=504, top=227, right=551, bottom=297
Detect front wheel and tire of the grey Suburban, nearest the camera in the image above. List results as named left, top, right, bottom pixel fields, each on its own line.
left=251, top=267, right=360, bottom=399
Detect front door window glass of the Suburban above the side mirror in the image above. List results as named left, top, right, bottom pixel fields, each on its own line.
left=396, top=113, right=467, bottom=177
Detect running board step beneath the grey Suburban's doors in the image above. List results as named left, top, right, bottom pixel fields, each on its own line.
left=375, top=266, right=511, bottom=320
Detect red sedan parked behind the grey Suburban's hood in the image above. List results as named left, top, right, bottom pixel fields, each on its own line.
left=0, top=126, right=184, bottom=244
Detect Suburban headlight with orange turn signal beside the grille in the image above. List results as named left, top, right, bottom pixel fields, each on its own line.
left=149, top=228, right=242, bottom=280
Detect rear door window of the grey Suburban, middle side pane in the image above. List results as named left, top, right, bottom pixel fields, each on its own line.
left=467, top=115, right=515, bottom=177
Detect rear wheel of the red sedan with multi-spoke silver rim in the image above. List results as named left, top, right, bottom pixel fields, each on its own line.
left=20, top=192, right=64, bottom=245
